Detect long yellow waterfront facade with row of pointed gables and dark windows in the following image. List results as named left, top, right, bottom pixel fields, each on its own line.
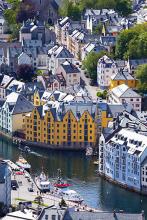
left=25, top=106, right=97, bottom=146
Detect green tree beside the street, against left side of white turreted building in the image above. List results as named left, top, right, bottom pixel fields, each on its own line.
left=83, top=51, right=107, bottom=81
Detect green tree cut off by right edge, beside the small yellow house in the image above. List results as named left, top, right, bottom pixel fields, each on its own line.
left=135, top=64, right=147, bottom=92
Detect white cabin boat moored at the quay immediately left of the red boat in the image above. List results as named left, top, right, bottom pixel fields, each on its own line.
left=35, top=172, right=51, bottom=192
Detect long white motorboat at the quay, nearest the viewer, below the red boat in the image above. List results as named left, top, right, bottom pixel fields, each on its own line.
left=57, top=189, right=83, bottom=203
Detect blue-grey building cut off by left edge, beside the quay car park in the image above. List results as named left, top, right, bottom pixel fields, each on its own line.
left=0, top=161, right=11, bottom=207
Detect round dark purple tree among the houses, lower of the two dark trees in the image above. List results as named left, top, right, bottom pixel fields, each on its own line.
left=16, top=64, right=34, bottom=82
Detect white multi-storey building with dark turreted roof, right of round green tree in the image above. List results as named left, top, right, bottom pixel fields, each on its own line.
left=97, top=55, right=118, bottom=89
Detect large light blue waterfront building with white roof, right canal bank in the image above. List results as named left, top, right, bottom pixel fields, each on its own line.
left=99, top=128, right=147, bottom=191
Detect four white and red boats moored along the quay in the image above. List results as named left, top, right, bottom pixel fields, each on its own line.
left=16, top=156, right=83, bottom=203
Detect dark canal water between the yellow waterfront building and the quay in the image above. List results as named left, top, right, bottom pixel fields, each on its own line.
left=0, top=137, right=147, bottom=219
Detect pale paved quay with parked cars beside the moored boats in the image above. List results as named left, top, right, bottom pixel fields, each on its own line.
left=7, top=160, right=98, bottom=211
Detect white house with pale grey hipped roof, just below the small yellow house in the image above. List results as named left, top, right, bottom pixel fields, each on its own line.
left=108, top=84, right=142, bottom=111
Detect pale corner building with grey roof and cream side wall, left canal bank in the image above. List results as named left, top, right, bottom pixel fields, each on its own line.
left=0, top=92, right=34, bottom=135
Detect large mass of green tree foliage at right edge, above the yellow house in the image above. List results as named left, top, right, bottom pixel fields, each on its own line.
left=115, top=23, right=147, bottom=59
